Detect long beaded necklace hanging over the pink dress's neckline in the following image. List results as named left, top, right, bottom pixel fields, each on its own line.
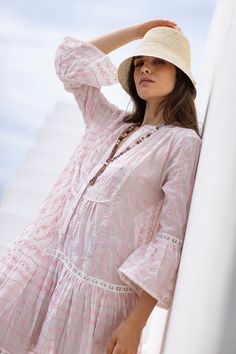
left=89, top=122, right=166, bottom=185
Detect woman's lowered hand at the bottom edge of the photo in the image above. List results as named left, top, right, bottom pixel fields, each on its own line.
left=106, top=321, right=142, bottom=354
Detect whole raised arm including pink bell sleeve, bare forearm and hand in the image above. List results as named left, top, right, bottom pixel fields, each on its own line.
left=55, top=20, right=176, bottom=135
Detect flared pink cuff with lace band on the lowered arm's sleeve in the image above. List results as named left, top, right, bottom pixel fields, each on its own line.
left=118, top=234, right=181, bottom=310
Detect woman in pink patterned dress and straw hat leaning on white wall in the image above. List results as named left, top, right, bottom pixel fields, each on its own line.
left=0, top=20, right=201, bottom=354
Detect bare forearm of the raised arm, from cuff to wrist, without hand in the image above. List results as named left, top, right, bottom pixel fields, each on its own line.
left=88, top=25, right=140, bottom=54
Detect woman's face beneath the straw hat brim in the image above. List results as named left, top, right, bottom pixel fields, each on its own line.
left=133, top=56, right=176, bottom=101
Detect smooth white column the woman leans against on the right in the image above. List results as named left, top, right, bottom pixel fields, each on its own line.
left=160, top=0, right=236, bottom=354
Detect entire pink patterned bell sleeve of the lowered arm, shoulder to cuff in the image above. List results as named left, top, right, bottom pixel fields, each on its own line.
left=118, top=132, right=201, bottom=310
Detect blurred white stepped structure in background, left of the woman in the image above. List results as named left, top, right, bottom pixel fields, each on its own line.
left=0, top=102, right=84, bottom=254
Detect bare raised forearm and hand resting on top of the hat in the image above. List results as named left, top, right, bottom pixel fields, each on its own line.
left=89, top=20, right=176, bottom=54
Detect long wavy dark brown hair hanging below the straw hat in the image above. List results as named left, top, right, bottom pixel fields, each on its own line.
left=123, top=58, right=201, bottom=137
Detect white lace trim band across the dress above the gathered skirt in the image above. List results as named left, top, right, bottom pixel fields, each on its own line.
left=47, top=249, right=134, bottom=293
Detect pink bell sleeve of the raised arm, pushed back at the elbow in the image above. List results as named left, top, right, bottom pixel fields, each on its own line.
left=55, top=36, right=123, bottom=128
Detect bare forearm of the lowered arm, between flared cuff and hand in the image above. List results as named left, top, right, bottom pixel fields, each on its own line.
left=127, top=290, right=157, bottom=329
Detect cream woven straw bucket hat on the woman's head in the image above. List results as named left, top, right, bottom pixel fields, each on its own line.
left=117, top=26, right=196, bottom=94
